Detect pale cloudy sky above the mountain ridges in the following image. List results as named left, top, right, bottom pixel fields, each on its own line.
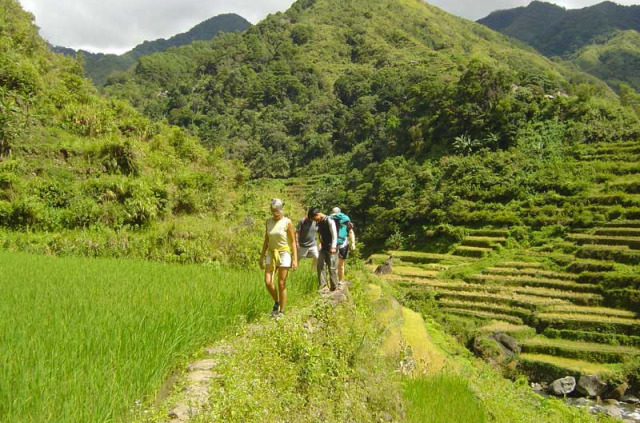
left=18, top=0, right=640, bottom=54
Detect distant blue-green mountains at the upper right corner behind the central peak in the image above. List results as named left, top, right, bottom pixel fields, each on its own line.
left=478, top=1, right=640, bottom=91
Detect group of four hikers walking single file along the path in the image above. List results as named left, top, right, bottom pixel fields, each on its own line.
left=260, top=198, right=356, bottom=317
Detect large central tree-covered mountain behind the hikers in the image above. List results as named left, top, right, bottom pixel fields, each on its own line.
left=106, top=0, right=639, bottom=245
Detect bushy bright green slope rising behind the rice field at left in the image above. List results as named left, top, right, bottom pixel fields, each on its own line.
left=0, top=0, right=259, bottom=261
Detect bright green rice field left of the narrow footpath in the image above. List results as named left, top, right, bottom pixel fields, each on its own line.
left=0, top=253, right=316, bottom=423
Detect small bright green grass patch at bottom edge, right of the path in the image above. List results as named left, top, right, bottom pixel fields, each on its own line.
left=404, top=374, right=485, bottom=423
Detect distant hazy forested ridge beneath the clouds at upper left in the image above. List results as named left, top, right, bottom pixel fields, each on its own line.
left=52, top=13, right=251, bottom=87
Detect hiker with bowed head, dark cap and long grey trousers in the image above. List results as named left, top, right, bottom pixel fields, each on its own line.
left=307, top=207, right=338, bottom=291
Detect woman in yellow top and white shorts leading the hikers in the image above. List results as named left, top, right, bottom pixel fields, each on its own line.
left=260, top=198, right=298, bottom=317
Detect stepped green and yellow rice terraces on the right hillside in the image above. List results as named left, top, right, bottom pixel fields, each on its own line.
left=370, top=138, right=640, bottom=389
